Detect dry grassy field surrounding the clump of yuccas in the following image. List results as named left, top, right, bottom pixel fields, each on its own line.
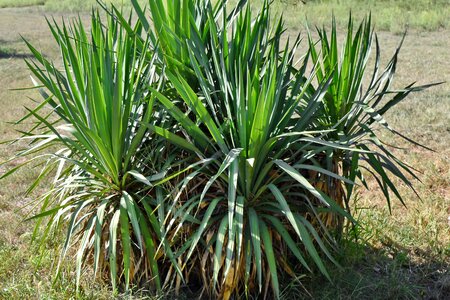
left=0, top=0, right=450, bottom=299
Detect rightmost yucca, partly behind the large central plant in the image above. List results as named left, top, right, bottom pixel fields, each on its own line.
left=308, top=15, right=434, bottom=232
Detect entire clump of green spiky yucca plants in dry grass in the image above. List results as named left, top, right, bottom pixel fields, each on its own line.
left=3, top=0, right=438, bottom=299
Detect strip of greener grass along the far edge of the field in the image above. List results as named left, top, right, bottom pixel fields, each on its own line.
left=0, top=0, right=450, bottom=33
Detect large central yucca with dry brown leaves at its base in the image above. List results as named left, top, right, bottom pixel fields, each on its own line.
left=143, top=2, right=356, bottom=299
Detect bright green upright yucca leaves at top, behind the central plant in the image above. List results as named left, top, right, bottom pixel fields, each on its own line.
left=121, top=0, right=246, bottom=85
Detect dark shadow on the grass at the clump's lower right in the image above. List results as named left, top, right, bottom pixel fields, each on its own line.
left=292, top=240, right=450, bottom=300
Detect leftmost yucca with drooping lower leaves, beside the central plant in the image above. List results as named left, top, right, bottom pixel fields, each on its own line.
left=2, top=8, right=177, bottom=288
